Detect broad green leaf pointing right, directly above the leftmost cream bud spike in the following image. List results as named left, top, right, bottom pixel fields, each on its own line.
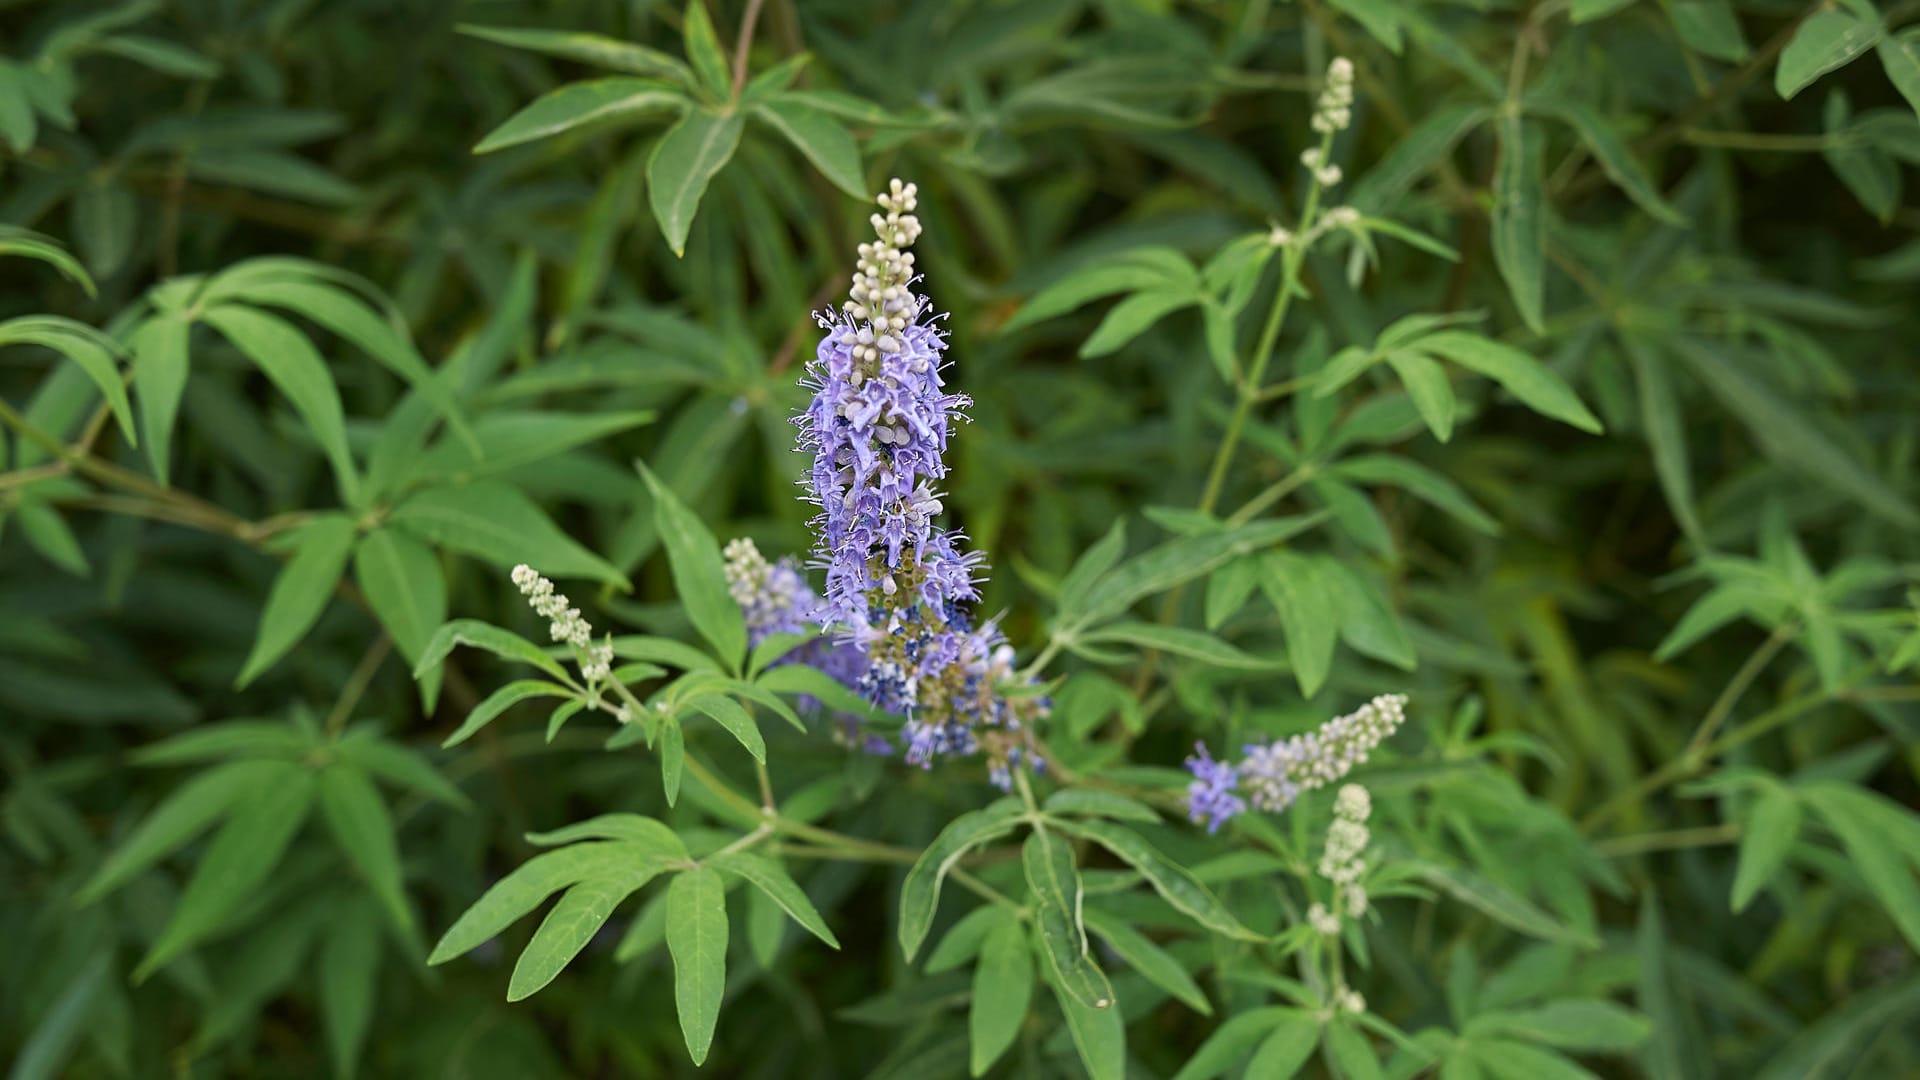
left=388, top=480, right=634, bottom=590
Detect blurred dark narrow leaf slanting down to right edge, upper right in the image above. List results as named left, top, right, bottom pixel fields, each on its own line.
left=1672, top=336, right=1920, bottom=528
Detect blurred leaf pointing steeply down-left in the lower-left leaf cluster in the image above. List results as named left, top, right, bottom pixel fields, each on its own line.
left=134, top=763, right=315, bottom=980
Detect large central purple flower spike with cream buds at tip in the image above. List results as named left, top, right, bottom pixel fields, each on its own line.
left=797, top=179, right=1046, bottom=786
